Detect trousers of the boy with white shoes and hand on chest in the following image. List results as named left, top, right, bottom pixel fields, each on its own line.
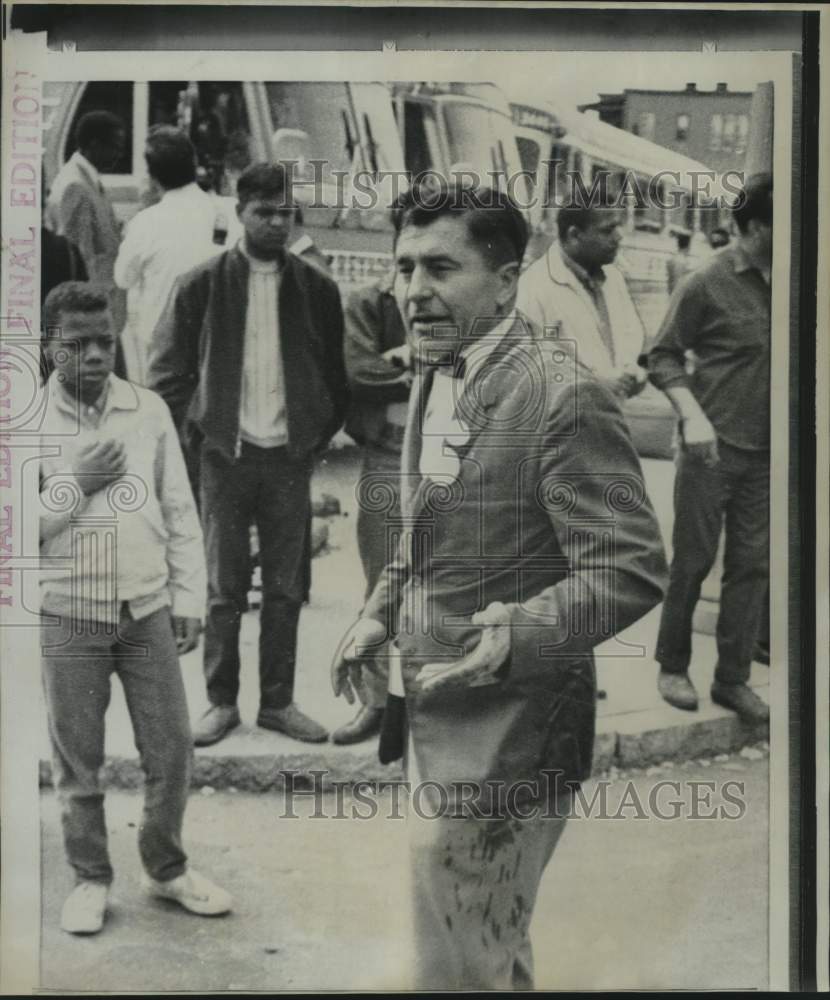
left=41, top=604, right=192, bottom=884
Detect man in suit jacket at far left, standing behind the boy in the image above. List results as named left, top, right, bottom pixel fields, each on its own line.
left=46, top=111, right=127, bottom=340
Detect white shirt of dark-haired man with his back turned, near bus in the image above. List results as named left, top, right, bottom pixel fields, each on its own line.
left=115, top=183, right=227, bottom=385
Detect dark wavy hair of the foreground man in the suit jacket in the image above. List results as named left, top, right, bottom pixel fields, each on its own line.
left=392, top=181, right=529, bottom=269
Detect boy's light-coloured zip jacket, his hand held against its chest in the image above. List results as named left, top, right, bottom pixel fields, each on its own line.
left=39, top=373, right=207, bottom=622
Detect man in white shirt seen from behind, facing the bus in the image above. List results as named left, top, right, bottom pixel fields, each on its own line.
left=115, top=125, right=227, bottom=385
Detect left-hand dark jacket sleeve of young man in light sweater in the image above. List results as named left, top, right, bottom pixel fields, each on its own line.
left=147, top=271, right=207, bottom=433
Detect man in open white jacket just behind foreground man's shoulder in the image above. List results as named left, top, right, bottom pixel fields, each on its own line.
left=518, top=204, right=647, bottom=399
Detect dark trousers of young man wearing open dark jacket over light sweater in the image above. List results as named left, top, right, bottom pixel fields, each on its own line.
left=201, top=442, right=313, bottom=711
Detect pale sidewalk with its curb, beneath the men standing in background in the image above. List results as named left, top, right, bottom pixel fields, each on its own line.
left=35, top=449, right=775, bottom=791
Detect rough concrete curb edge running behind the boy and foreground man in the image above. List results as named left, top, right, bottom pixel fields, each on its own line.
left=40, top=709, right=768, bottom=792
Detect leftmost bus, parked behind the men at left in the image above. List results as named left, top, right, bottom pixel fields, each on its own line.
left=44, top=80, right=404, bottom=286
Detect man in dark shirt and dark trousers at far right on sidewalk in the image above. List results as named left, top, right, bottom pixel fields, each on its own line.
left=649, top=174, right=772, bottom=722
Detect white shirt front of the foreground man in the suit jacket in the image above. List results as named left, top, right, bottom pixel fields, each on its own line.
left=418, top=312, right=516, bottom=480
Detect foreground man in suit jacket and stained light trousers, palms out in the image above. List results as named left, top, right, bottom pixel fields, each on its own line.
left=332, top=187, right=666, bottom=990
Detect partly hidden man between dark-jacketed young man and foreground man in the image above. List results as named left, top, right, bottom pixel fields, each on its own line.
left=331, top=277, right=412, bottom=743
